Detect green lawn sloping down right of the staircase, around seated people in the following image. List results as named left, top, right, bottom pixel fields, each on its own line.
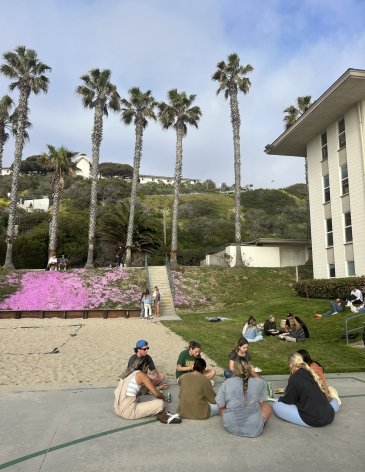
left=164, top=268, right=365, bottom=374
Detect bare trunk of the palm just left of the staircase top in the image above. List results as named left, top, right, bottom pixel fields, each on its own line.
left=125, top=120, right=143, bottom=267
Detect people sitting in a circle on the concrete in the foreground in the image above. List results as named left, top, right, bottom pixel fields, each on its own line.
left=114, top=337, right=341, bottom=437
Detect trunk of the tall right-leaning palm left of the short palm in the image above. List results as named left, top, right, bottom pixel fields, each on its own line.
left=3, top=87, right=30, bottom=269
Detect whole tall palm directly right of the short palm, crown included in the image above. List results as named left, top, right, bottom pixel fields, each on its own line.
left=76, top=69, right=120, bottom=269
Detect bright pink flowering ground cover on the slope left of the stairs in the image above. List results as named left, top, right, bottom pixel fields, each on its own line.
left=0, top=269, right=141, bottom=310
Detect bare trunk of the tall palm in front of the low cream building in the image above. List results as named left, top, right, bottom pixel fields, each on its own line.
left=229, top=87, right=243, bottom=267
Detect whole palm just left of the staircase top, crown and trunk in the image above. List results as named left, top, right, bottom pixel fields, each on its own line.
left=121, top=87, right=157, bottom=267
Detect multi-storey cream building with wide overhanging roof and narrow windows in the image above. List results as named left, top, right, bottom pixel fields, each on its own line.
left=266, top=69, right=365, bottom=278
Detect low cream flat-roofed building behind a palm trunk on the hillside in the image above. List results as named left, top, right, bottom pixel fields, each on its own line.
left=200, top=238, right=310, bottom=267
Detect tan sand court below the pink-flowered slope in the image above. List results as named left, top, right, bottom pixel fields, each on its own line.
left=0, top=318, right=221, bottom=391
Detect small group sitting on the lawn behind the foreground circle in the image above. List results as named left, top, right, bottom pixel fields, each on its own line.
left=242, top=313, right=309, bottom=343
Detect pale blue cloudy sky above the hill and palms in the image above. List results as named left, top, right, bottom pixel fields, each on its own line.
left=0, top=0, right=365, bottom=188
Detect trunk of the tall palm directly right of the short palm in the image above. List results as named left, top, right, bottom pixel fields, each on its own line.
left=85, top=103, right=104, bottom=269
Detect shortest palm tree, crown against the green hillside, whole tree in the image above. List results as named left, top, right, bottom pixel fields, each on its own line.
left=42, top=144, right=78, bottom=254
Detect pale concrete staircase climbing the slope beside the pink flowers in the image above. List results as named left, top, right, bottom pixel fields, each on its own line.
left=148, top=266, right=180, bottom=320
